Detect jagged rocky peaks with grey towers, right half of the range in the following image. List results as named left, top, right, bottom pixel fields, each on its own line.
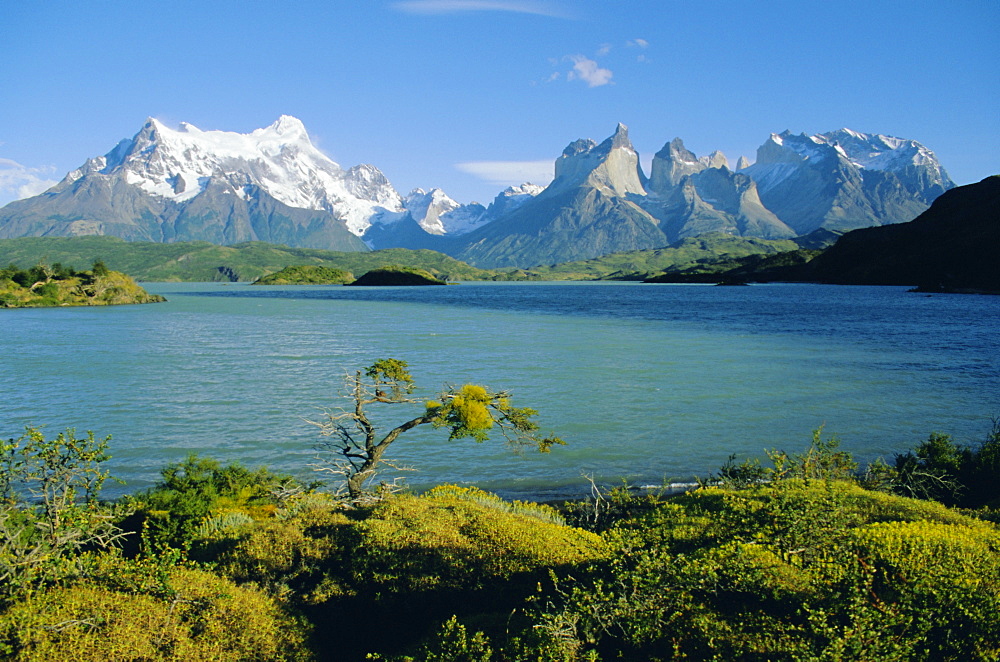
left=455, top=124, right=954, bottom=267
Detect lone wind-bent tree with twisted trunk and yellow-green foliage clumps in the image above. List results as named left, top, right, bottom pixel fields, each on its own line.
left=309, top=359, right=565, bottom=501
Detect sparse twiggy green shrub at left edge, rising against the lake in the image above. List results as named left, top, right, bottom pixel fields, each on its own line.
left=0, top=426, right=123, bottom=603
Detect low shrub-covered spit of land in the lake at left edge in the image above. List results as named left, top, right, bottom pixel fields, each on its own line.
left=0, top=261, right=165, bottom=308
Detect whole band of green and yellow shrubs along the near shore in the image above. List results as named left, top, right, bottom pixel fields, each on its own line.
left=0, top=412, right=1000, bottom=662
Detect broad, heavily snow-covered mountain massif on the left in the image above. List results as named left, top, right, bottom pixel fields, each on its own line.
left=0, top=115, right=420, bottom=251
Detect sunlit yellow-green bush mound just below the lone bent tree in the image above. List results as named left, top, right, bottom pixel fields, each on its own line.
left=207, top=486, right=606, bottom=604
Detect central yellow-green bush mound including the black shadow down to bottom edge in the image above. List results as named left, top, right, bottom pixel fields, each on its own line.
left=207, top=486, right=606, bottom=659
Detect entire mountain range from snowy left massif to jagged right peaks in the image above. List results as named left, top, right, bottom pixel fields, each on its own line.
left=0, top=116, right=954, bottom=268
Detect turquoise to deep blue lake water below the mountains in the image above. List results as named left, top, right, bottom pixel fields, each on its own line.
left=0, top=283, right=1000, bottom=498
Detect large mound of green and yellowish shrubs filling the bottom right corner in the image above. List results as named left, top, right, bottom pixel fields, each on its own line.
left=534, top=478, right=1000, bottom=660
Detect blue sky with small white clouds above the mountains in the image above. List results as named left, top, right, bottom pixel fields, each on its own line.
left=0, top=0, right=1000, bottom=204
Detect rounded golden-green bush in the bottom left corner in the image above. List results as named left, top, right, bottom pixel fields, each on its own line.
left=0, top=568, right=311, bottom=662
